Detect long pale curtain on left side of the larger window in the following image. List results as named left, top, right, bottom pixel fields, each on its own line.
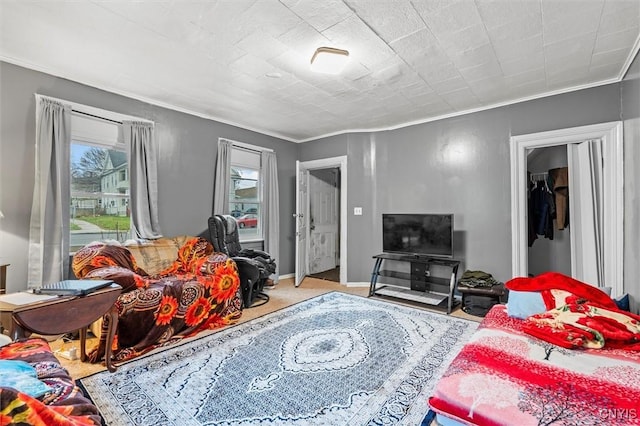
left=27, top=95, right=71, bottom=288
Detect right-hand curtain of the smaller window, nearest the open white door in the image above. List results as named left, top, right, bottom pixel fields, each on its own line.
left=260, top=151, right=280, bottom=282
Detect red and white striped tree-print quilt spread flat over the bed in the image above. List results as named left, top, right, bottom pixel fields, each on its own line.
left=429, top=305, right=640, bottom=426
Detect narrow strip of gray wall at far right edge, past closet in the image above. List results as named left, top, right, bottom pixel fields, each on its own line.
left=620, top=50, right=640, bottom=312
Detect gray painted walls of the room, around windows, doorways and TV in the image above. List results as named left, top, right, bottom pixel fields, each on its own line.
left=0, top=54, right=640, bottom=306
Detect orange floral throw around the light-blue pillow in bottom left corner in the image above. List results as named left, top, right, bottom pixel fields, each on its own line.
left=0, top=338, right=101, bottom=426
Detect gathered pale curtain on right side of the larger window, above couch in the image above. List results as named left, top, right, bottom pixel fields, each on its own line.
left=122, top=121, right=162, bottom=240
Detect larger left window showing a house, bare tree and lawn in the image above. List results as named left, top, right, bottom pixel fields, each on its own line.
left=69, top=112, right=131, bottom=252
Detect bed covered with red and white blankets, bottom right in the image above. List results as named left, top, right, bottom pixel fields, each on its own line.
left=429, top=274, right=640, bottom=426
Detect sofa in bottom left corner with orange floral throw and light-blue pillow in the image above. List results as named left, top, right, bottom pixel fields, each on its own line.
left=0, top=338, right=101, bottom=426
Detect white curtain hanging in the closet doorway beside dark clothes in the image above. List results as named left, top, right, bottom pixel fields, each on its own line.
left=569, top=139, right=607, bottom=287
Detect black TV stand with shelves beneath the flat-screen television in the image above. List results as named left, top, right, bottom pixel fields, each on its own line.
left=369, top=253, right=460, bottom=314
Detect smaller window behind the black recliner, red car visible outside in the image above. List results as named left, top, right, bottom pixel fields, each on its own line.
left=229, top=145, right=263, bottom=241
